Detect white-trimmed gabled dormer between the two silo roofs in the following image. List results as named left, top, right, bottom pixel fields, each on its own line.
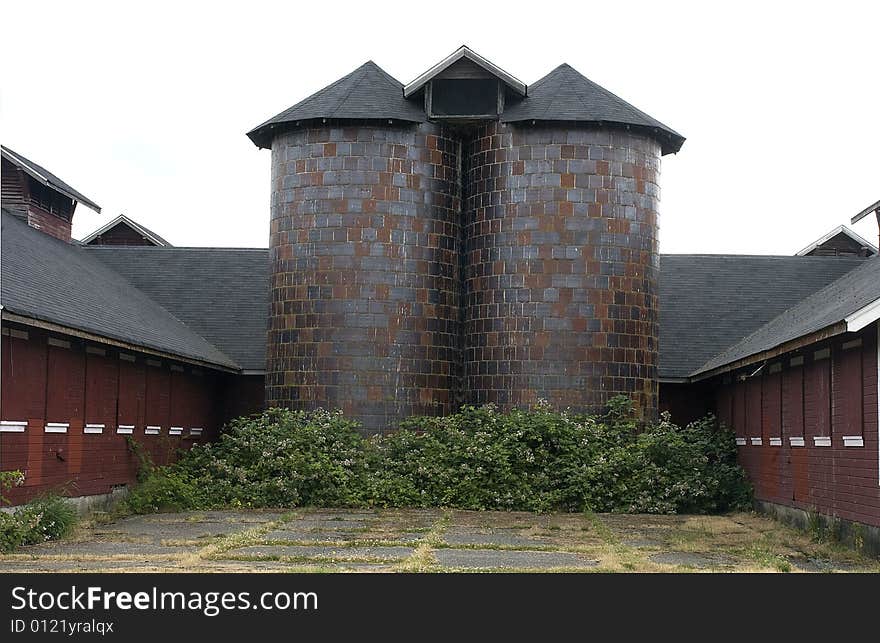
left=403, top=46, right=526, bottom=121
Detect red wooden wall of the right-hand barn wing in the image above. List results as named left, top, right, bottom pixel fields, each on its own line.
left=715, top=323, right=880, bottom=526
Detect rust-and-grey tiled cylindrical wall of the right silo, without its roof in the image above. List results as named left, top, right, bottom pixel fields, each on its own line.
left=464, top=123, right=660, bottom=417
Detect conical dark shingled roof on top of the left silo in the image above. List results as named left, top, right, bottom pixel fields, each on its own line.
left=248, top=60, right=425, bottom=148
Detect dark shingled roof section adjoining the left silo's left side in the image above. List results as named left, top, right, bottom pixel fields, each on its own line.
left=84, top=246, right=269, bottom=371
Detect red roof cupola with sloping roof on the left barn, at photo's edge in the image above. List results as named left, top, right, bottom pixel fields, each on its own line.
left=0, top=146, right=101, bottom=241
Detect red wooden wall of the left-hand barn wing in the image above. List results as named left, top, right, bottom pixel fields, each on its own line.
left=0, top=323, right=226, bottom=504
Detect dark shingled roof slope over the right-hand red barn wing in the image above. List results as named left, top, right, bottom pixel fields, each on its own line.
left=694, top=257, right=880, bottom=375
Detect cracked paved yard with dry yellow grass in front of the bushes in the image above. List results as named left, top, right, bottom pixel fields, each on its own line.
left=0, top=509, right=880, bottom=573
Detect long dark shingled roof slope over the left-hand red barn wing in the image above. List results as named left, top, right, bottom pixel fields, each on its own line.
left=0, top=211, right=237, bottom=370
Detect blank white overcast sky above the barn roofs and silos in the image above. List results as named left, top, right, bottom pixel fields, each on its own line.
left=0, top=0, right=880, bottom=254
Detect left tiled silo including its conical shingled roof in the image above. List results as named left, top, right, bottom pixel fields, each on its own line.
left=252, top=63, right=460, bottom=432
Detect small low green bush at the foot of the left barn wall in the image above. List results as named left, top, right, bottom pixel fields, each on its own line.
left=0, top=495, right=77, bottom=552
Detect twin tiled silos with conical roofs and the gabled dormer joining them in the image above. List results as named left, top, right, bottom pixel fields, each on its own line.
left=249, top=47, right=684, bottom=432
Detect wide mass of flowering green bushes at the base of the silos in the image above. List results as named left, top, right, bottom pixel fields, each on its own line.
left=128, top=398, right=751, bottom=513
